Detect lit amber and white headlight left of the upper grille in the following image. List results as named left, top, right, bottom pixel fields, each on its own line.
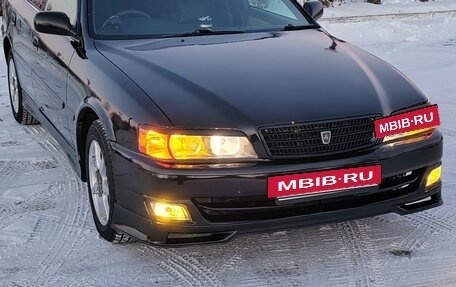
left=138, top=127, right=257, bottom=160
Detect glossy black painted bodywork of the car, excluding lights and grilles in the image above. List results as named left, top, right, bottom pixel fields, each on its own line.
left=4, top=0, right=442, bottom=243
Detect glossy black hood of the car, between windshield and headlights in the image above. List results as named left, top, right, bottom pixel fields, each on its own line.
left=96, top=29, right=427, bottom=129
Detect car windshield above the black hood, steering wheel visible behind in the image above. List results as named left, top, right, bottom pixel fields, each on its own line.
left=91, top=0, right=310, bottom=38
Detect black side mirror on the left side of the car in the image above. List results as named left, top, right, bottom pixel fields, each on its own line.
left=34, top=12, right=73, bottom=36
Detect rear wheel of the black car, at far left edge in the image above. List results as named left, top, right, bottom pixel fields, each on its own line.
left=7, top=51, right=39, bottom=125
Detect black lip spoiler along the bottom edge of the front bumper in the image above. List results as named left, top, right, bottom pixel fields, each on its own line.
left=113, top=186, right=443, bottom=247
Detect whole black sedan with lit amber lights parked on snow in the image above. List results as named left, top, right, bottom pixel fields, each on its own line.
left=3, top=0, right=443, bottom=244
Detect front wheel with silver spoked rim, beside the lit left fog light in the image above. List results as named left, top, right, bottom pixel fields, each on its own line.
left=85, top=120, right=132, bottom=243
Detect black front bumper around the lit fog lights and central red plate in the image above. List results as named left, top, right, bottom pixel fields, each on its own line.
left=109, top=131, right=443, bottom=244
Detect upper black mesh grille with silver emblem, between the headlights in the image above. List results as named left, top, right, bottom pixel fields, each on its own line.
left=260, top=116, right=376, bottom=158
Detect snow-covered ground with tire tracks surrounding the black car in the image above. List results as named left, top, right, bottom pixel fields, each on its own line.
left=0, top=0, right=456, bottom=287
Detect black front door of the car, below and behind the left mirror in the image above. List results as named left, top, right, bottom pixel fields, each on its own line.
left=32, top=0, right=78, bottom=142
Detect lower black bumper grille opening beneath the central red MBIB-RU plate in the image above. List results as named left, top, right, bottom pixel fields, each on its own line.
left=193, top=168, right=426, bottom=222
